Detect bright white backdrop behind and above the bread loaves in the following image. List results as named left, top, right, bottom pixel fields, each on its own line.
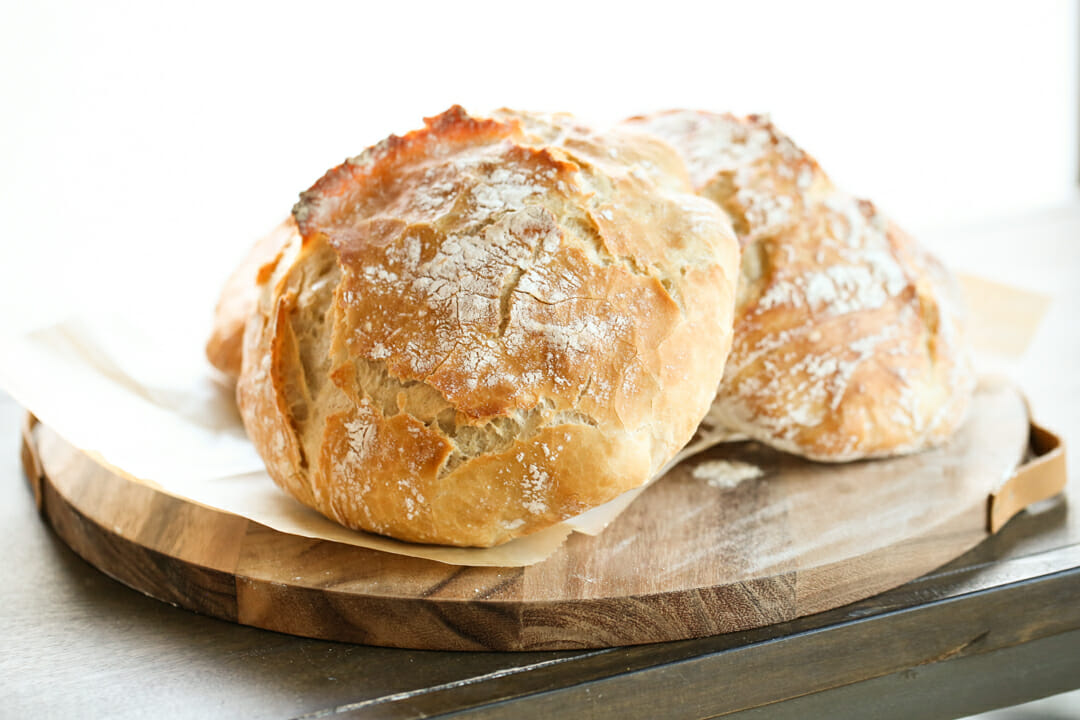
left=0, top=0, right=1078, bottom=338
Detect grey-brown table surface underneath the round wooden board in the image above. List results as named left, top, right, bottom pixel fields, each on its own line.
left=0, top=207, right=1080, bottom=720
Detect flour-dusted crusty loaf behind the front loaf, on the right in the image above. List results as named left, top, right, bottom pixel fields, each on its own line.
left=627, top=111, right=974, bottom=462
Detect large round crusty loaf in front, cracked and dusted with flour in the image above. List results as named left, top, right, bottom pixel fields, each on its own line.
left=238, top=107, right=739, bottom=546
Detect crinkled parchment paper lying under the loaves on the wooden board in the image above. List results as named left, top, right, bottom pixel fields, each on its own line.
left=0, top=277, right=1049, bottom=567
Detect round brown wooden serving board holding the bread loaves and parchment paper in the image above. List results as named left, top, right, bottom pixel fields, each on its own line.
left=25, top=383, right=1028, bottom=650
